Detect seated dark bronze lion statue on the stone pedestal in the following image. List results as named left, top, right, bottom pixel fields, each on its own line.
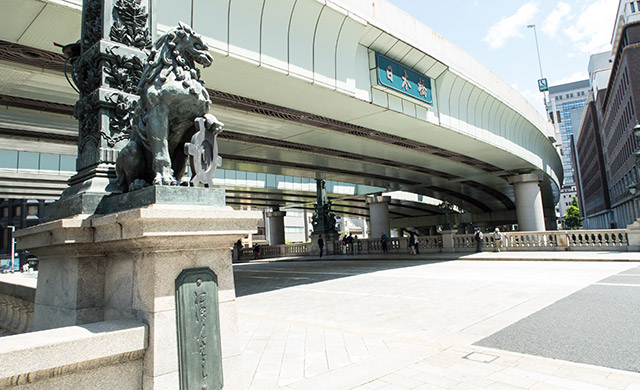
left=116, top=23, right=223, bottom=192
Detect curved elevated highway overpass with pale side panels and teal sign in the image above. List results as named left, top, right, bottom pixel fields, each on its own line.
left=0, top=0, right=563, bottom=227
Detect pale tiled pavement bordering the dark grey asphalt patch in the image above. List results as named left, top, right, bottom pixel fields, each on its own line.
left=235, top=258, right=640, bottom=390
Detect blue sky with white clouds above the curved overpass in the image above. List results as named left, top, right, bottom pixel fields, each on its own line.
left=390, top=0, right=619, bottom=112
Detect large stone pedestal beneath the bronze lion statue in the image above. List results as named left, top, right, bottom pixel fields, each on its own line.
left=16, top=200, right=262, bottom=390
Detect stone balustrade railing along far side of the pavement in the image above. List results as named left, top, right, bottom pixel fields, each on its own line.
left=239, top=229, right=640, bottom=261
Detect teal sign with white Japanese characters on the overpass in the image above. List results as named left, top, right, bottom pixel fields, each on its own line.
left=376, top=53, right=433, bottom=104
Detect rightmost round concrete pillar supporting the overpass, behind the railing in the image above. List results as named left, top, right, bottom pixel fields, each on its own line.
left=509, top=173, right=545, bottom=232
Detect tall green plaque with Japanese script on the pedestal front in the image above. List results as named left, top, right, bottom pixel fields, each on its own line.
left=176, top=268, right=223, bottom=390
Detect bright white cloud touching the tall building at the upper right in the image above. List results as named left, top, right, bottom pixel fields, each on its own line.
left=565, top=0, right=618, bottom=54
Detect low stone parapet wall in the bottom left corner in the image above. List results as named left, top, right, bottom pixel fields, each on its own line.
left=0, top=320, right=147, bottom=390
